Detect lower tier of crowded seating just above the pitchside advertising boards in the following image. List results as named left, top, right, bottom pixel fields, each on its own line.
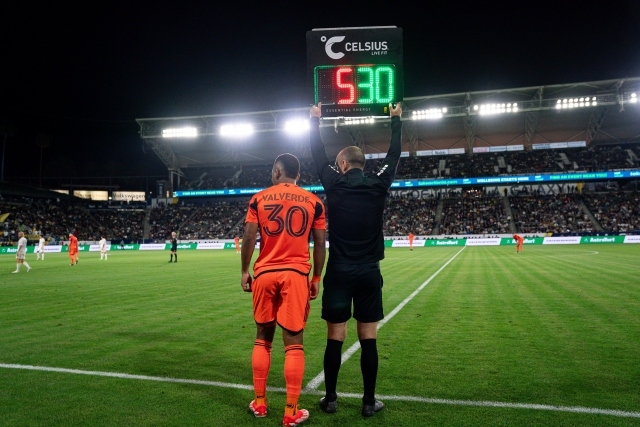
left=0, top=186, right=640, bottom=244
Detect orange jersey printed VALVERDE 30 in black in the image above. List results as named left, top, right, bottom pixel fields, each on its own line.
left=246, top=184, right=327, bottom=276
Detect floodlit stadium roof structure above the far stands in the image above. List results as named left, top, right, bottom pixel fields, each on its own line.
left=136, top=77, right=640, bottom=181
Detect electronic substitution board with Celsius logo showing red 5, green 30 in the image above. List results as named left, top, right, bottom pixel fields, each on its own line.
left=307, top=27, right=404, bottom=118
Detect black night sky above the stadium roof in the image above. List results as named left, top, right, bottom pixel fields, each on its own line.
left=0, top=0, right=640, bottom=184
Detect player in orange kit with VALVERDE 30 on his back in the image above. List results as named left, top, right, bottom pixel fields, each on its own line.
left=240, top=154, right=326, bottom=426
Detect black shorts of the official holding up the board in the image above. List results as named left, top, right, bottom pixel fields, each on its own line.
left=322, top=262, right=384, bottom=323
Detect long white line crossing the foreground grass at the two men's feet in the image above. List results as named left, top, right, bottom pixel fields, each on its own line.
left=0, top=363, right=640, bottom=418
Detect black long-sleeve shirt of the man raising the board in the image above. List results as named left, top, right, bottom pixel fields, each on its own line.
left=309, top=116, right=402, bottom=264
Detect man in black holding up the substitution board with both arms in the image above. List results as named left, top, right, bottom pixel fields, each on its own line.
left=309, top=103, right=402, bottom=417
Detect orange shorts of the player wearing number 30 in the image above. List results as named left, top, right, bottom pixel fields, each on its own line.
left=251, top=271, right=310, bottom=332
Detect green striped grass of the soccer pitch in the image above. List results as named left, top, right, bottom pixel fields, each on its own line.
left=0, top=245, right=640, bottom=426
